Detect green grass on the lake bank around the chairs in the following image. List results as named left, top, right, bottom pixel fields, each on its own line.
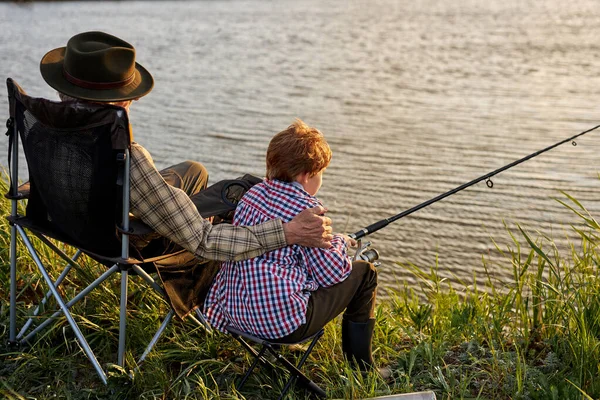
left=0, top=173, right=600, bottom=399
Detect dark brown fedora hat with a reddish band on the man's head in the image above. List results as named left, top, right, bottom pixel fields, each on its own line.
left=40, top=32, right=154, bottom=101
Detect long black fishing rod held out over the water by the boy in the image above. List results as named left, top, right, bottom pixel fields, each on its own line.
left=348, top=125, right=600, bottom=240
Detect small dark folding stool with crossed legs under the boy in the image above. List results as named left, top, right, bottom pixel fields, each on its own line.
left=225, top=326, right=326, bottom=400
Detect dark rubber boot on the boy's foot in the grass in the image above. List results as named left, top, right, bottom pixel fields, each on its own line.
left=342, top=319, right=392, bottom=380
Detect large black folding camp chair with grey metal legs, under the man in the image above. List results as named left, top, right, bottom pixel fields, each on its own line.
left=6, top=78, right=210, bottom=383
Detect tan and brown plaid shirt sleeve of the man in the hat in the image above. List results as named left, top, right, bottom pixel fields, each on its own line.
left=130, top=143, right=287, bottom=261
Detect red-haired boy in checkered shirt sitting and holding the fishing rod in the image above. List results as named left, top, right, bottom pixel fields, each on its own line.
left=205, top=120, right=377, bottom=368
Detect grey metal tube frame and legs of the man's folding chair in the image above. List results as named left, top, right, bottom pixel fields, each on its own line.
left=5, top=78, right=212, bottom=384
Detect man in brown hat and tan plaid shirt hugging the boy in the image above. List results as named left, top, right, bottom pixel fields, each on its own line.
left=40, top=32, right=332, bottom=315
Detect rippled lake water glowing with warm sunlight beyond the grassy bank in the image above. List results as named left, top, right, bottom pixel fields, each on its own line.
left=0, top=0, right=600, bottom=294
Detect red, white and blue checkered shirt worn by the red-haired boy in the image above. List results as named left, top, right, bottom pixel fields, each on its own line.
left=205, top=180, right=352, bottom=339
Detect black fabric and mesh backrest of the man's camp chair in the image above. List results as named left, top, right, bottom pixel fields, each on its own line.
left=7, top=79, right=131, bottom=256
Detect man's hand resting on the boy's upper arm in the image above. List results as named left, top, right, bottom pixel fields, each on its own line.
left=283, top=206, right=333, bottom=249
